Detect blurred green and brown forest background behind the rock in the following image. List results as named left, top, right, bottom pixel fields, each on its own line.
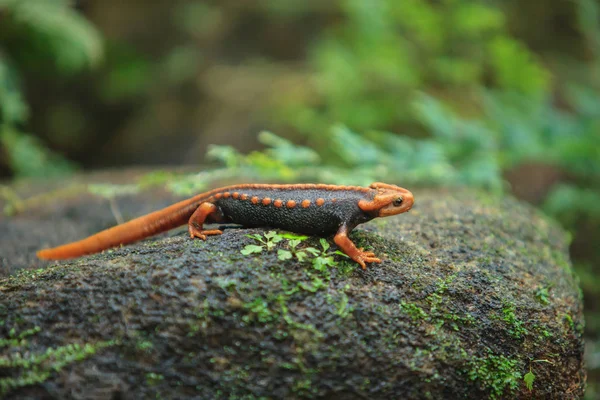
left=0, top=0, right=600, bottom=399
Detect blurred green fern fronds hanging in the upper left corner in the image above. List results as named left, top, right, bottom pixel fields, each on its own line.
left=0, top=0, right=102, bottom=176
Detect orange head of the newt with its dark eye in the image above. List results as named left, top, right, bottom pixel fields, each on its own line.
left=358, top=182, right=414, bottom=217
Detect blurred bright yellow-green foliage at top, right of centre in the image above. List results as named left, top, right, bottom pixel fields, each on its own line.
left=281, top=0, right=550, bottom=140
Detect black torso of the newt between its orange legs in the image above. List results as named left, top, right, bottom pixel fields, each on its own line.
left=214, top=188, right=375, bottom=236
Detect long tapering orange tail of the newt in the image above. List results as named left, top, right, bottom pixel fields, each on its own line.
left=37, top=194, right=206, bottom=260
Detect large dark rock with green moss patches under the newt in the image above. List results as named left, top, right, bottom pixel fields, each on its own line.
left=0, top=179, right=585, bottom=399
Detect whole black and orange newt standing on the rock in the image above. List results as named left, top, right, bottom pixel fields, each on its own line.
left=37, top=182, right=414, bottom=269
